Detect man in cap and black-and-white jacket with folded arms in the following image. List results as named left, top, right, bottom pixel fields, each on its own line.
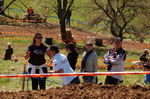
left=104, top=37, right=126, bottom=85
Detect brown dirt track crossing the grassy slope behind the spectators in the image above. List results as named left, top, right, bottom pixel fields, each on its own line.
left=0, top=24, right=150, bottom=51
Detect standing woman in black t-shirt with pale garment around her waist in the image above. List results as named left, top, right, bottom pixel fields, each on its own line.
left=25, top=33, right=48, bottom=90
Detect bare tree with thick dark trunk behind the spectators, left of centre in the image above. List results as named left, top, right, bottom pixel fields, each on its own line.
left=38, top=0, right=74, bottom=42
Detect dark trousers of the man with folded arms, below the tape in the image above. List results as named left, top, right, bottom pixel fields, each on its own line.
left=105, top=76, right=123, bottom=85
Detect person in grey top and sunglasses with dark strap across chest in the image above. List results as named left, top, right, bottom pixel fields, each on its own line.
left=81, top=41, right=98, bottom=83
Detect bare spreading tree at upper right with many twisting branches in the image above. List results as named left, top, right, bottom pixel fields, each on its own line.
left=92, top=0, right=147, bottom=38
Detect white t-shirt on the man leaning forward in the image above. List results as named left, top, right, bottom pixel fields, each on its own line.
left=53, top=53, right=76, bottom=85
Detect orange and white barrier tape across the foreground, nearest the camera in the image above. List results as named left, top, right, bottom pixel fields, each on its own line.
left=0, top=71, right=150, bottom=78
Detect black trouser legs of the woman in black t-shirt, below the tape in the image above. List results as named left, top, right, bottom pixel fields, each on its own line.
left=31, top=77, right=46, bottom=90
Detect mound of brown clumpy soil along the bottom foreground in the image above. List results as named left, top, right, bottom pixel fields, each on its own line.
left=0, top=84, right=150, bottom=99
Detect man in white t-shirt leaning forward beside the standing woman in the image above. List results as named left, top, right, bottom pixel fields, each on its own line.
left=49, top=45, right=80, bottom=86
